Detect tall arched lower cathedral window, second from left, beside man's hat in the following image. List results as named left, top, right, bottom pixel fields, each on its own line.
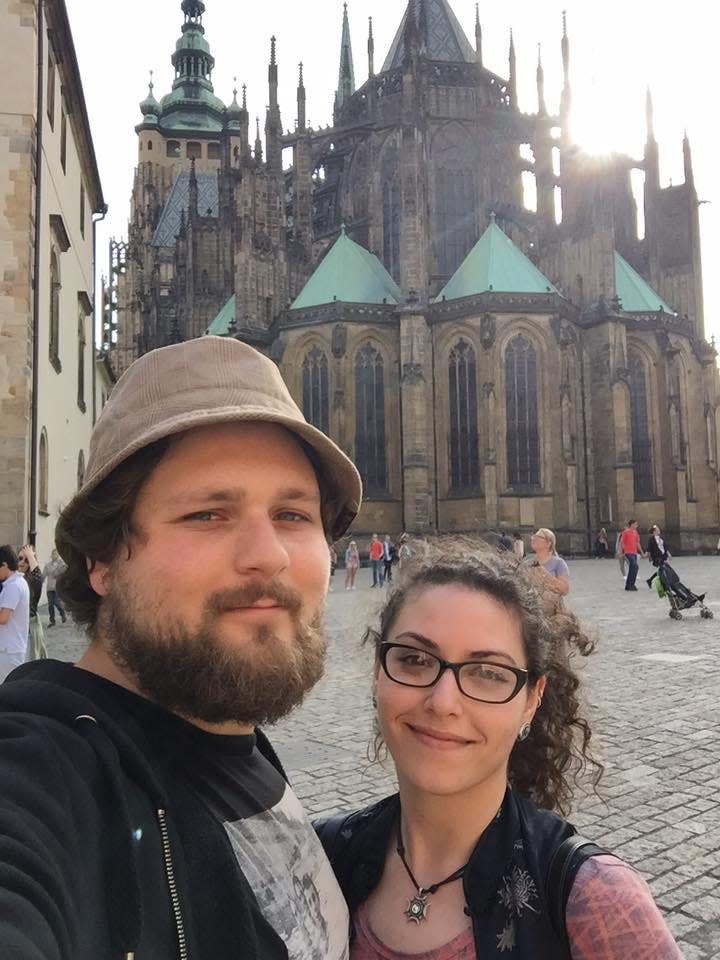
left=355, top=343, right=387, bottom=496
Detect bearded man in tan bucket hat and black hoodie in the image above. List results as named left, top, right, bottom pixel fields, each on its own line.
left=0, top=337, right=361, bottom=960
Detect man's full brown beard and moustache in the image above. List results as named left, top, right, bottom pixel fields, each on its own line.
left=96, top=576, right=326, bottom=725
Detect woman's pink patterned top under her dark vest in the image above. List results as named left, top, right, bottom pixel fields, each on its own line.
left=350, top=856, right=683, bottom=960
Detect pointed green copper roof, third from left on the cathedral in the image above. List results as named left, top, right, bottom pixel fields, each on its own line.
left=438, top=221, right=558, bottom=300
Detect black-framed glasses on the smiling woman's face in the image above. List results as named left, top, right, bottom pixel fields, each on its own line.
left=380, top=641, right=528, bottom=703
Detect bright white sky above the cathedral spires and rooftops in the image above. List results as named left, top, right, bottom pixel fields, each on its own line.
left=66, top=0, right=720, bottom=347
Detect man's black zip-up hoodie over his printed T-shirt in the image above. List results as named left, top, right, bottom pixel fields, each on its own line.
left=0, top=660, right=287, bottom=960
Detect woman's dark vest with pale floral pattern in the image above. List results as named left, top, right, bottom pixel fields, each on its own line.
left=318, top=790, right=604, bottom=960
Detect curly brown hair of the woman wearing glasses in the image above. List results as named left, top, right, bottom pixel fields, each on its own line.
left=365, top=538, right=604, bottom=814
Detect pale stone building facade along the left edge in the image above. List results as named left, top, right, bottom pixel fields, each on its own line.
left=0, top=0, right=104, bottom=557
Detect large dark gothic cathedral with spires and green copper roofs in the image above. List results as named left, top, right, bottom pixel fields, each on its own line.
left=111, top=0, right=720, bottom=553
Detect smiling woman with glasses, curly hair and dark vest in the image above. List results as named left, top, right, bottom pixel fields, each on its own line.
left=317, top=544, right=681, bottom=960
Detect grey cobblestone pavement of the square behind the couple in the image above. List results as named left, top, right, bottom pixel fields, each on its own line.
left=48, top=557, right=720, bottom=960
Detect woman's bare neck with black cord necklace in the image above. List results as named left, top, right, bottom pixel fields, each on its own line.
left=400, top=777, right=507, bottom=884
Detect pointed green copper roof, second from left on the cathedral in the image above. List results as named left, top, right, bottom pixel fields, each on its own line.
left=290, top=227, right=401, bottom=310
